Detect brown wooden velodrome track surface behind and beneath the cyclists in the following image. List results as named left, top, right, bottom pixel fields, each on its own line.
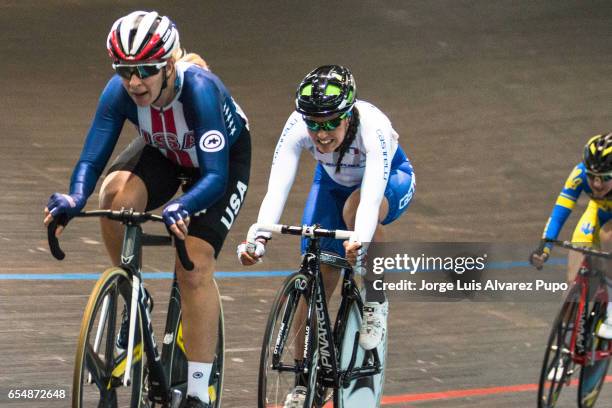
left=0, top=0, right=612, bottom=408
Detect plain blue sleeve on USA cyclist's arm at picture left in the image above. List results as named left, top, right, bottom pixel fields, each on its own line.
left=70, top=76, right=130, bottom=198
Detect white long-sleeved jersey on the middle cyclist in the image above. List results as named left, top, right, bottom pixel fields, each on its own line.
left=257, top=100, right=398, bottom=242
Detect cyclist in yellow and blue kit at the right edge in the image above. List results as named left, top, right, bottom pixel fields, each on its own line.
left=530, top=133, right=612, bottom=339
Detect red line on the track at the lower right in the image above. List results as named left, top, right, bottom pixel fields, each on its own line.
left=382, top=375, right=612, bottom=405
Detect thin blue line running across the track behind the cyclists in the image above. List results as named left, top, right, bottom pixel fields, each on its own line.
left=0, top=258, right=567, bottom=281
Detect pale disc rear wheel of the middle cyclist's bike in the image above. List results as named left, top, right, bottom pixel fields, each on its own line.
left=334, top=288, right=388, bottom=408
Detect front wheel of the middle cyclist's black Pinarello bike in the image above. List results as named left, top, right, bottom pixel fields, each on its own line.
left=257, top=273, right=318, bottom=408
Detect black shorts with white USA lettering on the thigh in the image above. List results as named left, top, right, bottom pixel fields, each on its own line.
left=108, top=127, right=251, bottom=258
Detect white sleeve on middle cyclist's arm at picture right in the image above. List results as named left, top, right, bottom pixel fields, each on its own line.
left=355, top=121, right=395, bottom=243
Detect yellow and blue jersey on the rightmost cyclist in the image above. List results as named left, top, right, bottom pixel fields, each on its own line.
left=542, top=163, right=612, bottom=249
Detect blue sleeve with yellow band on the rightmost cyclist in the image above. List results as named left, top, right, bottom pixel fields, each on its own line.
left=542, top=163, right=587, bottom=244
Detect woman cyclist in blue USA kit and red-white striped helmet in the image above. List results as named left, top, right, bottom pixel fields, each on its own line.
left=44, top=11, right=251, bottom=408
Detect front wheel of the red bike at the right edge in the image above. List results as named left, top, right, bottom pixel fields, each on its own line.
left=538, top=285, right=580, bottom=408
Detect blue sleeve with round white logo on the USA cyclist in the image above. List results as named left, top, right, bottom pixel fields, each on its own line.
left=178, top=77, right=230, bottom=214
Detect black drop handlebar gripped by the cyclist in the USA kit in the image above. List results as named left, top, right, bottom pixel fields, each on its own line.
left=47, top=209, right=194, bottom=271
